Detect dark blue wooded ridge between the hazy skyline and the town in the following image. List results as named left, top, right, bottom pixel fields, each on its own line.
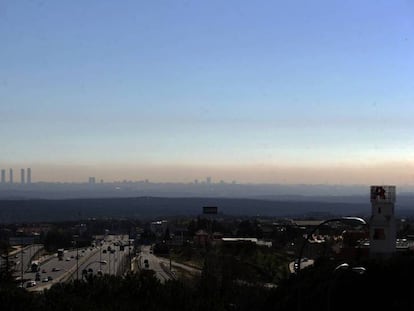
left=0, top=197, right=369, bottom=223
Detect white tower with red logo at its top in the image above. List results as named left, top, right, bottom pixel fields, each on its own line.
left=369, top=186, right=396, bottom=257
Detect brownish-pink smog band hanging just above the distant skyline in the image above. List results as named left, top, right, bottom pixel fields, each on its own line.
left=2, top=163, right=414, bottom=187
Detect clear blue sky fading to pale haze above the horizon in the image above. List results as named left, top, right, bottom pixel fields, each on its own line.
left=0, top=0, right=414, bottom=184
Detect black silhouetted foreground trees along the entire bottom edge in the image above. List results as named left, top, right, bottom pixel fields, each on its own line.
left=0, top=256, right=414, bottom=311
